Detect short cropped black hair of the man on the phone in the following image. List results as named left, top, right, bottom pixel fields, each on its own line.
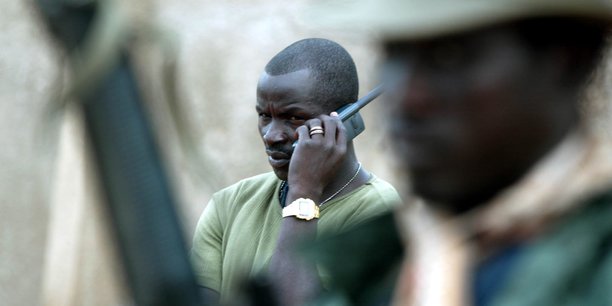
left=265, top=38, right=359, bottom=109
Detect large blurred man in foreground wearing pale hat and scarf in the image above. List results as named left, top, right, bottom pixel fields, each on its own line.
left=308, top=0, right=612, bottom=306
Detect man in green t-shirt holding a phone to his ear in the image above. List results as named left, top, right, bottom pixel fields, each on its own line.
left=192, top=38, right=400, bottom=305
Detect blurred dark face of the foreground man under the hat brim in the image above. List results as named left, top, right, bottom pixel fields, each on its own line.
left=384, top=27, right=572, bottom=212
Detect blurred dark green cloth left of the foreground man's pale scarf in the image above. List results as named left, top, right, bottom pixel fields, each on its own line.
left=304, top=212, right=403, bottom=306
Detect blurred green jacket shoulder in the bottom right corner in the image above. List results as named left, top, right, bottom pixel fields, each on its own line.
left=493, top=194, right=612, bottom=306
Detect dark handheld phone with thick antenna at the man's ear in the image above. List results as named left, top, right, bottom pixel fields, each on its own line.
left=293, top=84, right=383, bottom=148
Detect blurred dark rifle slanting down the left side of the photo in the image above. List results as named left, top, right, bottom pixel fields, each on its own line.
left=36, top=0, right=205, bottom=306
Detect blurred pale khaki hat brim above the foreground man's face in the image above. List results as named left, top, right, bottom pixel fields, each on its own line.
left=306, top=0, right=612, bottom=39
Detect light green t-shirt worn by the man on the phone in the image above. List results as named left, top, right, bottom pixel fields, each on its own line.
left=191, top=172, right=400, bottom=300
